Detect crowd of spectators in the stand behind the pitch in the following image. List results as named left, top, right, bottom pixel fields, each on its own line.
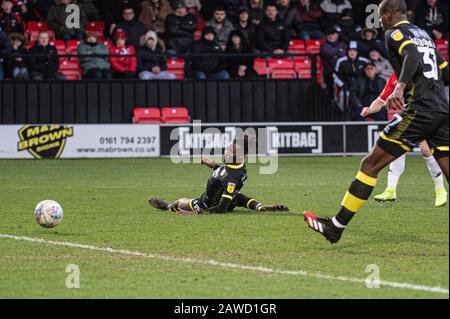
left=0, top=0, right=448, bottom=117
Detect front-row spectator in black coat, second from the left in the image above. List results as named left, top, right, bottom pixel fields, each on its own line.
left=28, top=31, right=65, bottom=80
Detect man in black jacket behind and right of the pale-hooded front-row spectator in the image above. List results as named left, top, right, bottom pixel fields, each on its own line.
left=166, top=0, right=198, bottom=55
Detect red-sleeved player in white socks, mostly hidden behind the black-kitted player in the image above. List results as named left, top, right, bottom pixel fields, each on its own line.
left=361, top=73, right=447, bottom=207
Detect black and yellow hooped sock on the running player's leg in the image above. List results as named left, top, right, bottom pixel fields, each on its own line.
left=333, top=171, right=377, bottom=228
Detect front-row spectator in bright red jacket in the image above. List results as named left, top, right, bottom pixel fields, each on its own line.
left=109, top=29, right=137, bottom=79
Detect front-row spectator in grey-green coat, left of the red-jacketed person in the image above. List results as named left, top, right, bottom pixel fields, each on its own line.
left=78, top=32, right=111, bottom=80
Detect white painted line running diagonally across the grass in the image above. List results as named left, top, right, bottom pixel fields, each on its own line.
left=0, top=234, right=449, bottom=295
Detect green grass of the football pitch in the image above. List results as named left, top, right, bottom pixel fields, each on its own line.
left=0, top=157, right=449, bottom=298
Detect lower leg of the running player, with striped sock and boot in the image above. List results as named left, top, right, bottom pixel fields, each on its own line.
left=303, top=145, right=396, bottom=244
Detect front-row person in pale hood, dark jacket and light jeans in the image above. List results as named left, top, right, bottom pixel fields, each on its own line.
left=138, top=31, right=175, bottom=80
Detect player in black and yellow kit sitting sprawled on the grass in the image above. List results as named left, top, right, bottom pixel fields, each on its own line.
left=149, top=139, right=289, bottom=215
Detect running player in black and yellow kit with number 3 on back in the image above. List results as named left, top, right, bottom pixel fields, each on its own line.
left=304, top=0, right=449, bottom=243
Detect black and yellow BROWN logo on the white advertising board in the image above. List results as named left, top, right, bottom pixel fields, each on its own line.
left=17, top=125, right=73, bottom=159
